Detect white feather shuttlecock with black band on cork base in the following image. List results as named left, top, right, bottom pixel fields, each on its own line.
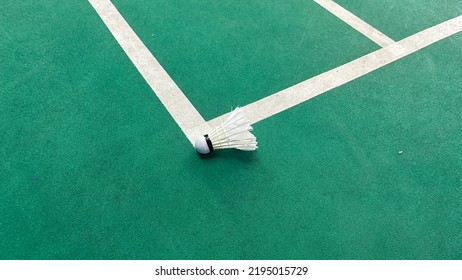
left=194, top=107, right=258, bottom=154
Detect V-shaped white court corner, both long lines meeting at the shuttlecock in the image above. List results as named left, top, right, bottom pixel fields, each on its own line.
left=89, top=0, right=462, bottom=143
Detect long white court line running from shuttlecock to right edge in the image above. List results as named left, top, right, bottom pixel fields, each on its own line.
left=203, top=16, right=462, bottom=131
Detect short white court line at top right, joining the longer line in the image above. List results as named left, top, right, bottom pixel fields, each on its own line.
left=314, top=0, right=395, bottom=47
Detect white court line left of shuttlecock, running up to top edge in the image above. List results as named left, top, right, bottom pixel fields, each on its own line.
left=89, top=0, right=205, bottom=143
